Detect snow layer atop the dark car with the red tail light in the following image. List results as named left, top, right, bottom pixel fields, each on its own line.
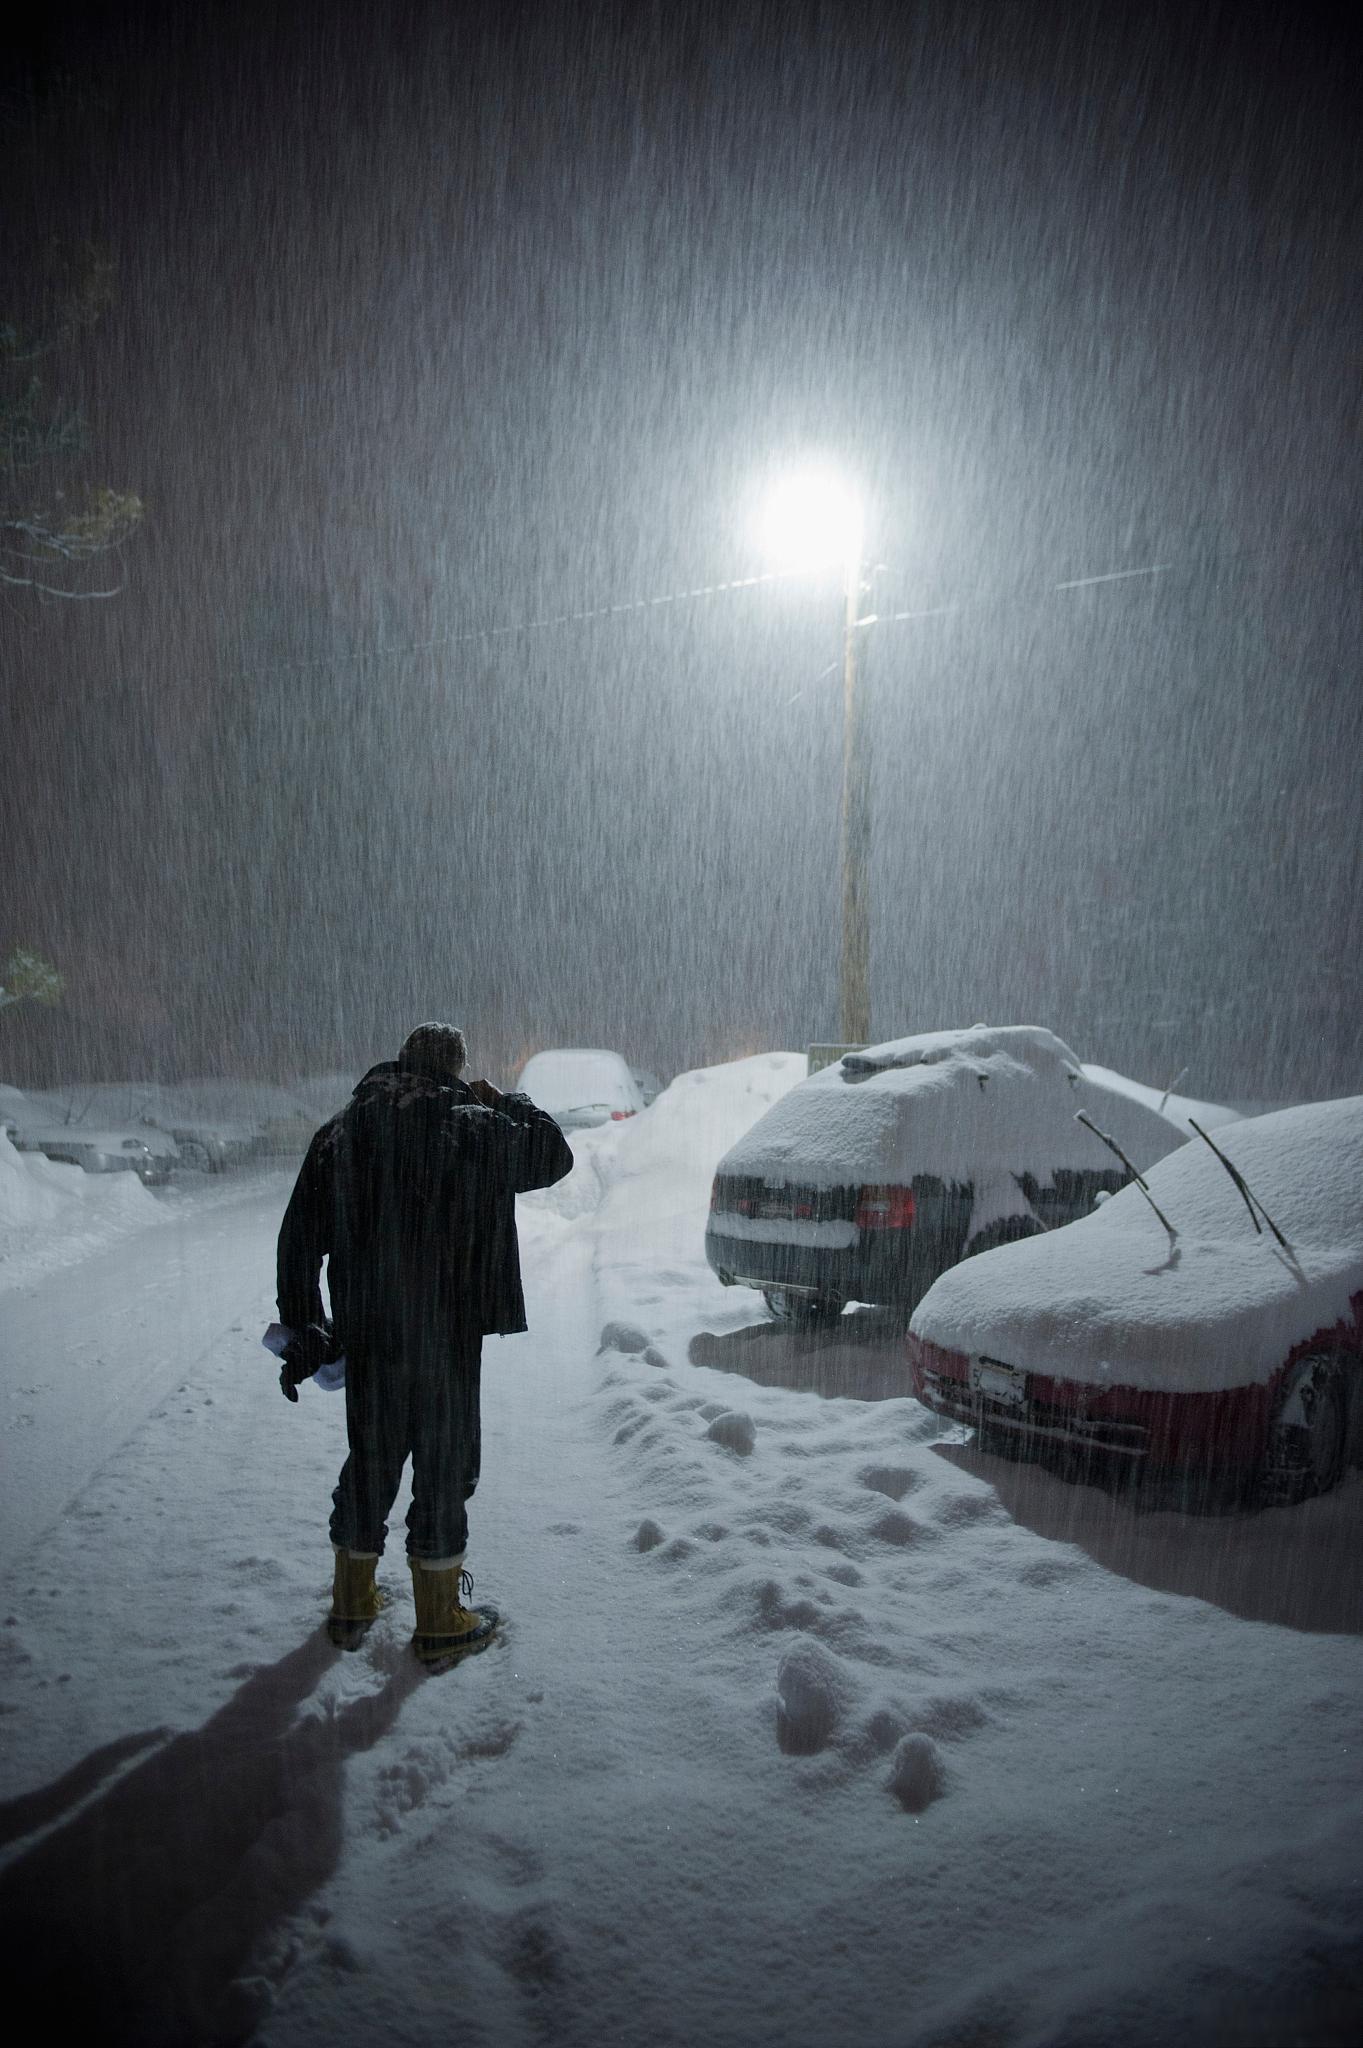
left=720, top=1024, right=1179, bottom=1186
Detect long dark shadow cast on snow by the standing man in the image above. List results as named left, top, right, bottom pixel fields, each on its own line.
left=0, top=1632, right=426, bottom=2048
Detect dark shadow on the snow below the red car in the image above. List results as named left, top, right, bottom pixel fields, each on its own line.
left=933, top=1444, right=1363, bottom=1636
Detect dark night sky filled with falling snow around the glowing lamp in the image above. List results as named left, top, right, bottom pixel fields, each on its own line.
left=0, top=4, right=1363, bottom=1098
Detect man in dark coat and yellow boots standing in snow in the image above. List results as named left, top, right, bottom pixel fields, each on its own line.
left=278, top=1024, right=573, bottom=1663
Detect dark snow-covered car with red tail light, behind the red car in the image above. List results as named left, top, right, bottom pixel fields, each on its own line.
left=706, top=1024, right=1187, bottom=1321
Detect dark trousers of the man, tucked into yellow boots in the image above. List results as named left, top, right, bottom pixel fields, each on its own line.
left=332, top=1333, right=483, bottom=1559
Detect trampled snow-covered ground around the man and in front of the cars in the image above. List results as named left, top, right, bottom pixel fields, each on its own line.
left=0, top=1055, right=1363, bottom=2048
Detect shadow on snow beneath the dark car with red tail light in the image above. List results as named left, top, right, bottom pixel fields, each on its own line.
left=686, top=1309, right=913, bottom=1401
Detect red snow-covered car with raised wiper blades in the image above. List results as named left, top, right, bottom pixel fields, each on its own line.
left=907, top=1096, right=1363, bottom=1501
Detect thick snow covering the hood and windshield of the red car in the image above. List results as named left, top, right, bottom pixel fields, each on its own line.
left=911, top=1096, right=1363, bottom=1393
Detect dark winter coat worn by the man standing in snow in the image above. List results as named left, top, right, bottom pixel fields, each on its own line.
left=278, top=1063, right=573, bottom=1358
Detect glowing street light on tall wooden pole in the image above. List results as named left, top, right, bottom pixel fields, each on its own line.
left=761, top=465, right=870, bottom=1044
